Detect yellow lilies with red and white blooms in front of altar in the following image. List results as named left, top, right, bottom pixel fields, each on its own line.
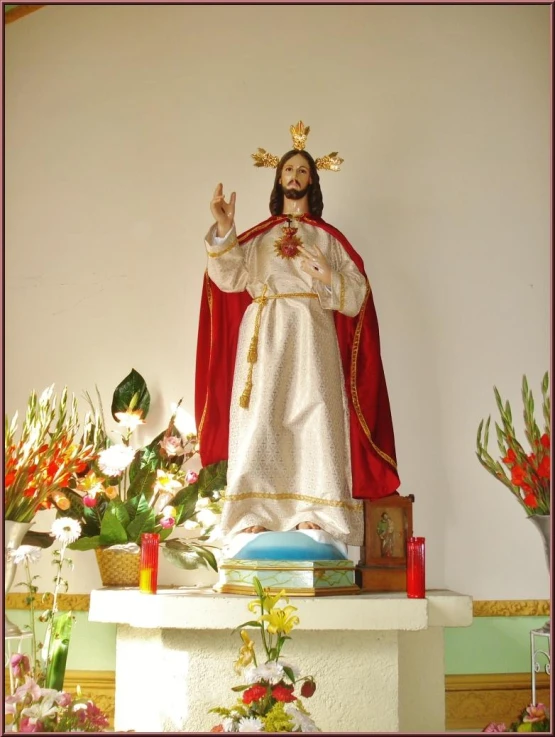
left=210, top=578, right=321, bottom=732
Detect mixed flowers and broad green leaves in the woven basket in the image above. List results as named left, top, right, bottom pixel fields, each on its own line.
left=57, top=369, right=225, bottom=570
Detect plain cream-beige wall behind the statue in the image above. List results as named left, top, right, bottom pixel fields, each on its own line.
left=5, top=5, right=550, bottom=599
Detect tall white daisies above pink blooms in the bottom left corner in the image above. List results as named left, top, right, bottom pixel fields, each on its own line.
left=4, top=518, right=108, bottom=732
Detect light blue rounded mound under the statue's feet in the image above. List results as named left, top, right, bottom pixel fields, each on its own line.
left=233, top=531, right=345, bottom=561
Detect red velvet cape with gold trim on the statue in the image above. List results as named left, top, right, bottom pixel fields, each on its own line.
left=195, top=216, right=400, bottom=499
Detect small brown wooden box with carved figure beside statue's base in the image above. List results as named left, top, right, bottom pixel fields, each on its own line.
left=357, top=494, right=414, bottom=592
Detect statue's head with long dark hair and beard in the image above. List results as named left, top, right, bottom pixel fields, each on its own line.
left=270, top=149, right=324, bottom=218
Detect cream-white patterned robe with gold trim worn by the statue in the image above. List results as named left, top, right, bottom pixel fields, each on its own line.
left=206, top=216, right=367, bottom=545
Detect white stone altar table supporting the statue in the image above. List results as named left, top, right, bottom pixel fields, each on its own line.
left=89, top=588, right=472, bottom=733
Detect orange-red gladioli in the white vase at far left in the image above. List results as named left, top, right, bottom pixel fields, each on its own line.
left=4, top=385, right=94, bottom=523
